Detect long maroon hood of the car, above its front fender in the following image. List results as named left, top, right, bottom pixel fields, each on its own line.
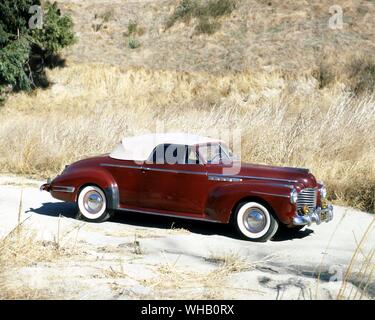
left=229, top=162, right=317, bottom=188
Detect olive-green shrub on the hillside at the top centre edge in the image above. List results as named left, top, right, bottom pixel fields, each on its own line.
left=166, top=0, right=236, bottom=34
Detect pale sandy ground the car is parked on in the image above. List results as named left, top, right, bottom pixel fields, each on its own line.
left=0, top=177, right=375, bottom=299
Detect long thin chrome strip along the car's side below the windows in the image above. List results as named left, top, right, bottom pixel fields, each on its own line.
left=99, top=163, right=298, bottom=183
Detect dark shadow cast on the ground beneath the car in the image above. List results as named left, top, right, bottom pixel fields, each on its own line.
left=26, top=202, right=313, bottom=241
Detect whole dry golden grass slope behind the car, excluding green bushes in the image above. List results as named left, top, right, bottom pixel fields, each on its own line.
left=0, top=0, right=375, bottom=211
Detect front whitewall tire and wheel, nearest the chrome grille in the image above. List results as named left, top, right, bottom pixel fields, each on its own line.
left=234, top=201, right=279, bottom=242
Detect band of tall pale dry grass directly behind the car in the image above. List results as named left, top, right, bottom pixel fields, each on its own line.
left=0, top=64, right=375, bottom=210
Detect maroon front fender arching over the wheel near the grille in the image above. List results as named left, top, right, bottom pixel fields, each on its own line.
left=206, top=181, right=295, bottom=224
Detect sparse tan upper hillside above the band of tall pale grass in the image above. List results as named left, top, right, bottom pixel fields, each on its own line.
left=58, top=0, right=375, bottom=74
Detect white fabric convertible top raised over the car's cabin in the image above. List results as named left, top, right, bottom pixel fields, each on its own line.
left=109, top=133, right=222, bottom=161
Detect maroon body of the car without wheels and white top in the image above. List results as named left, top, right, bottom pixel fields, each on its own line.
left=41, top=134, right=332, bottom=241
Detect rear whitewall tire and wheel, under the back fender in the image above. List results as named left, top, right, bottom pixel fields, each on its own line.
left=77, top=186, right=112, bottom=222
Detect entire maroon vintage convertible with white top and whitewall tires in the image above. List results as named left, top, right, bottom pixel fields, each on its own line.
left=41, top=133, right=333, bottom=241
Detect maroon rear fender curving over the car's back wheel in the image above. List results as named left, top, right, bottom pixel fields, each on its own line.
left=50, top=167, right=119, bottom=209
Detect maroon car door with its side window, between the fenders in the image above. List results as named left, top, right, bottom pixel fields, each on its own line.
left=139, top=144, right=207, bottom=215
